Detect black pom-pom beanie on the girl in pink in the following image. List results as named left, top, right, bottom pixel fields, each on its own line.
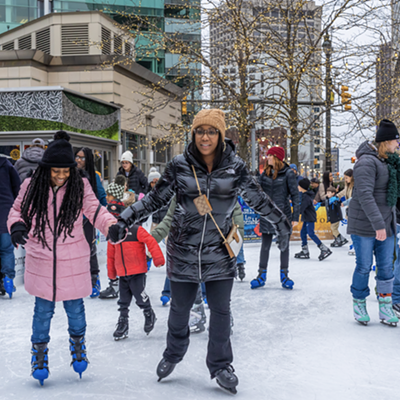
left=39, top=131, right=77, bottom=168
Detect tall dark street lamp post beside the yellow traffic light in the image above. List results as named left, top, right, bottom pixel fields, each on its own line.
left=322, top=33, right=332, bottom=172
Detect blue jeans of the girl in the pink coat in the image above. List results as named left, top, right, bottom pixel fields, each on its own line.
left=31, top=297, right=86, bottom=343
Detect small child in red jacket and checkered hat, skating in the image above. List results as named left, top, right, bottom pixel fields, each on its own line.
left=107, top=182, right=165, bottom=340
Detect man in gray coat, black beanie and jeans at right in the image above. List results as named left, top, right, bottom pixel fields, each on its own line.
left=347, top=120, right=400, bottom=326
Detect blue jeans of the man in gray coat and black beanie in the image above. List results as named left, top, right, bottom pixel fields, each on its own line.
left=350, top=235, right=395, bottom=300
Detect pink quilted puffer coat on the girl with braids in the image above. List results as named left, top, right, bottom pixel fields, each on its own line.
left=7, top=178, right=116, bottom=301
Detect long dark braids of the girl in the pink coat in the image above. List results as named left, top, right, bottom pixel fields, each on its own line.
left=21, top=166, right=84, bottom=250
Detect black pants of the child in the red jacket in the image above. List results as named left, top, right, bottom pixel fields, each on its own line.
left=118, top=274, right=151, bottom=317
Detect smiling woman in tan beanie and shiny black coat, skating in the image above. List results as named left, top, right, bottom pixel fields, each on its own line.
left=109, top=109, right=291, bottom=393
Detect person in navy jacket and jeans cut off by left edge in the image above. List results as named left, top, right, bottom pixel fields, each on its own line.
left=0, top=157, right=21, bottom=299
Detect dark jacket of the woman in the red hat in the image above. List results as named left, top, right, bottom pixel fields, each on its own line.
left=258, top=163, right=300, bottom=234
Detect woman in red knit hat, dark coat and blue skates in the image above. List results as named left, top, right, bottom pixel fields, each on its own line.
left=251, top=146, right=300, bottom=289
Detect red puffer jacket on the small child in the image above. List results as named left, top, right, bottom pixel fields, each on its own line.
left=107, top=225, right=165, bottom=279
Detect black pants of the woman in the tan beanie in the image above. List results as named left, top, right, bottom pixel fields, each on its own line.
left=164, top=279, right=233, bottom=378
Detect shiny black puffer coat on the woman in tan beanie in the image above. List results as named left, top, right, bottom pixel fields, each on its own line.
left=121, top=139, right=291, bottom=283
